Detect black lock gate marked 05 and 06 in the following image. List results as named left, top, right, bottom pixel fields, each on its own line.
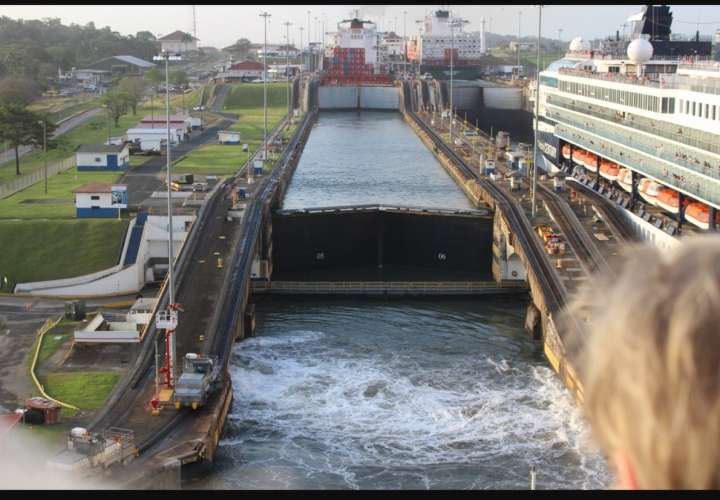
left=272, top=212, right=493, bottom=279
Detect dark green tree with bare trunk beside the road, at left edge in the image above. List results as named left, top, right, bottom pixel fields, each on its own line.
left=0, top=103, right=56, bottom=175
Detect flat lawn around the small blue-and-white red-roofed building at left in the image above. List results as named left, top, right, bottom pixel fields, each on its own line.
left=0, top=168, right=120, bottom=219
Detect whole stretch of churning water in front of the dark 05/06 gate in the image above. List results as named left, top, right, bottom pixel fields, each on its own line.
left=194, top=298, right=609, bottom=489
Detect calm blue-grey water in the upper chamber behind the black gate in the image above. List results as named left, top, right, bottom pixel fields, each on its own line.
left=283, top=111, right=472, bottom=209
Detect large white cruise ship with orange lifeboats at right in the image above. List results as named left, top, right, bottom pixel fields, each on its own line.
left=531, top=5, right=720, bottom=245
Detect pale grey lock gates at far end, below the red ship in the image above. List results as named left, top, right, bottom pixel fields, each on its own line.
left=319, top=85, right=400, bottom=109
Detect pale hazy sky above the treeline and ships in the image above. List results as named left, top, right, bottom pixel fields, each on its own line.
left=0, top=4, right=720, bottom=48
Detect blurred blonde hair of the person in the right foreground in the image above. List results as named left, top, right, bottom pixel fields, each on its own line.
left=569, top=235, right=720, bottom=489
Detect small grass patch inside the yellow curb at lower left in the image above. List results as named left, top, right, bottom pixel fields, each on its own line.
left=41, top=372, right=120, bottom=413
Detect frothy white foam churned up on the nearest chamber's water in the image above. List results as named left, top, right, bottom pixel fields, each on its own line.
left=221, top=320, right=607, bottom=488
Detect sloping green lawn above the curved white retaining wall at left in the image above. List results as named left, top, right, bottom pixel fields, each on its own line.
left=0, top=219, right=128, bottom=286
